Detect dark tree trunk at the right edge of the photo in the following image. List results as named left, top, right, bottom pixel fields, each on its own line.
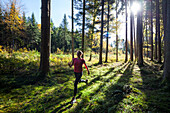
left=164, top=0, right=170, bottom=84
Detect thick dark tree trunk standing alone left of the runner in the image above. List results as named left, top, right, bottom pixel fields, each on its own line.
left=40, top=0, right=51, bottom=75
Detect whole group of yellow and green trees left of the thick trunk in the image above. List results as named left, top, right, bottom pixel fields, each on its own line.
left=0, top=0, right=41, bottom=51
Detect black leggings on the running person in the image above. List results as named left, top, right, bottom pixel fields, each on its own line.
left=74, top=72, right=86, bottom=96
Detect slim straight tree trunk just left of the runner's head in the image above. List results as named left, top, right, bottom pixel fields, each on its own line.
left=71, top=0, right=74, bottom=59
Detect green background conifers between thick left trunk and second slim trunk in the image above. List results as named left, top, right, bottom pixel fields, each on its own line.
left=51, top=15, right=81, bottom=53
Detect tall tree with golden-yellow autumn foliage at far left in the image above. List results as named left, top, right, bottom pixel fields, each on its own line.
left=1, top=1, right=22, bottom=49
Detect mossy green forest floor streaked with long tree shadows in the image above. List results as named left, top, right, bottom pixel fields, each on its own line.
left=0, top=51, right=170, bottom=113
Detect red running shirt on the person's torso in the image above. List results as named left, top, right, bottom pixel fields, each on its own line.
left=73, top=58, right=85, bottom=73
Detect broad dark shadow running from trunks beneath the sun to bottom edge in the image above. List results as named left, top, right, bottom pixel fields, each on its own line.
left=99, top=62, right=135, bottom=113
